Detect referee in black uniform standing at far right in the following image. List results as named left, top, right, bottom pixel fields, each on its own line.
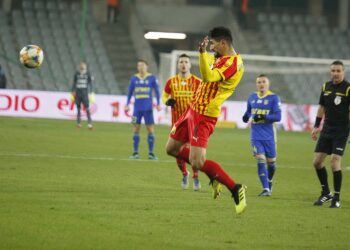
left=311, top=61, right=350, bottom=208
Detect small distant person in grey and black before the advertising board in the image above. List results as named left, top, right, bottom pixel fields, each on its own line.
left=72, top=62, right=94, bottom=129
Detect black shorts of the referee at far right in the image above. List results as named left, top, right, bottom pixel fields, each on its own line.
left=315, top=134, right=348, bottom=156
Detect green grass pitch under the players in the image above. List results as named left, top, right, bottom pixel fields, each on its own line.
left=0, top=117, right=350, bottom=249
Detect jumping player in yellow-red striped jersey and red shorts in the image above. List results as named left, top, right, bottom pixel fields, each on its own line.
left=166, top=27, right=247, bottom=214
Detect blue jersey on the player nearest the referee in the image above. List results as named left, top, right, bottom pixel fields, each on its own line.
left=245, top=91, right=281, bottom=141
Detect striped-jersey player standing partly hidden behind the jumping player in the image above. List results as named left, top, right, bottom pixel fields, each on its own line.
left=162, top=54, right=201, bottom=191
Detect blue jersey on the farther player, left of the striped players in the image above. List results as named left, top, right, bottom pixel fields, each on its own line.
left=126, top=74, right=160, bottom=111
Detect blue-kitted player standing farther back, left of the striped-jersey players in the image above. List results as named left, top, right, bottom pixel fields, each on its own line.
left=125, top=60, right=161, bottom=160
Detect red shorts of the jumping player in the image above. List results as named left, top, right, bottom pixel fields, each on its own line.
left=170, top=108, right=218, bottom=148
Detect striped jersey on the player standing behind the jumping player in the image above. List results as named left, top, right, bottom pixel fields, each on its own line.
left=164, top=74, right=201, bottom=124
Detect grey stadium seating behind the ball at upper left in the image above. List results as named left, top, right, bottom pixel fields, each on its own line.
left=0, top=0, right=121, bottom=94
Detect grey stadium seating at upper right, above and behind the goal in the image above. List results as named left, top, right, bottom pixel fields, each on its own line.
left=257, top=13, right=350, bottom=103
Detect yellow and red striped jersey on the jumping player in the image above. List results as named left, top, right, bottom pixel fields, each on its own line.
left=191, top=53, right=244, bottom=117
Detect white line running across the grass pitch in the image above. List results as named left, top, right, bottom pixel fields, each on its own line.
left=0, top=153, right=330, bottom=170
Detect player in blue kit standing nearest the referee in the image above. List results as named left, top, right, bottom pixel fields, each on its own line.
left=243, top=75, right=281, bottom=196
